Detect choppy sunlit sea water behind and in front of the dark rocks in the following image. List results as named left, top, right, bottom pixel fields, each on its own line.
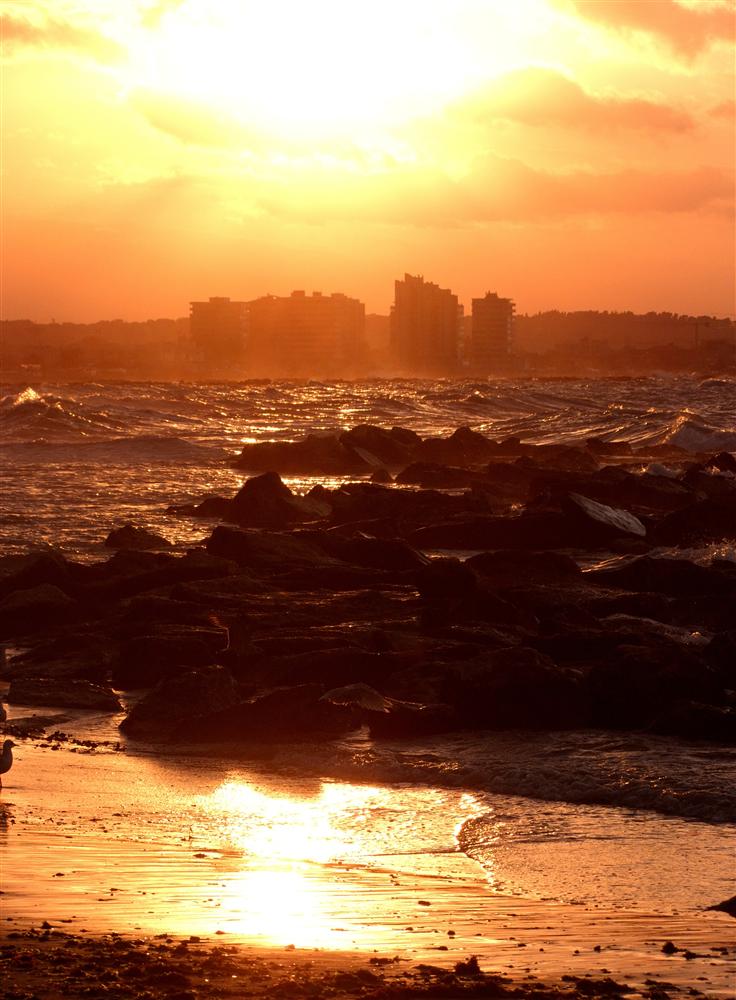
left=0, top=375, right=736, bottom=944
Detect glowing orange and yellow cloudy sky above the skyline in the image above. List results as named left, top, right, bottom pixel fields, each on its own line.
left=0, top=0, right=736, bottom=321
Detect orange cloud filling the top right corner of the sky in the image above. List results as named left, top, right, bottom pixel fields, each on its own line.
left=553, top=0, right=736, bottom=59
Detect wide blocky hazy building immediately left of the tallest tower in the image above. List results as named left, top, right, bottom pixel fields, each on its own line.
left=248, top=291, right=365, bottom=376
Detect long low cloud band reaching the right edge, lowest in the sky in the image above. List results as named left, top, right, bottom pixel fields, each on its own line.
left=251, top=154, right=734, bottom=226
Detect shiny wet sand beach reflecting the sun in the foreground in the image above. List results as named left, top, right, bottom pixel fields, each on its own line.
left=0, top=720, right=736, bottom=1000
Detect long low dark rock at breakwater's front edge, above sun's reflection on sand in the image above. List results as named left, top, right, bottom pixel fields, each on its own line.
left=181, top=684, right=358, bottom=743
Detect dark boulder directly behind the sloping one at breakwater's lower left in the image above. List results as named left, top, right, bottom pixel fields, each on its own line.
left=112, top=625, right=227, bottom=691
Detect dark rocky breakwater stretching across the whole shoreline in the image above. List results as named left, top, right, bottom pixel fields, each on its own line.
left=0, top=427, right=736, bottom=753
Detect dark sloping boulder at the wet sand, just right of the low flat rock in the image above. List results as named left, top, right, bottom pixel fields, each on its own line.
left=120, top=666, right=241, bottom=739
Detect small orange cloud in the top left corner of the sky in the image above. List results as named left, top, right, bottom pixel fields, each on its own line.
left=0, top=12, right=125, bottom=64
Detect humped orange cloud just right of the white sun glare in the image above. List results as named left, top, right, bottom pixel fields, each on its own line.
left=457, top=67, right=695, bottom=132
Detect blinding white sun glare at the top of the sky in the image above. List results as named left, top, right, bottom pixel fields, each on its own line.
left=122, top=0, right=548, bottom=146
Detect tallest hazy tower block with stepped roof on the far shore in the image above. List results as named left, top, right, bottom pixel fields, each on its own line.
left=391, top=274, right=463, bottom=375
